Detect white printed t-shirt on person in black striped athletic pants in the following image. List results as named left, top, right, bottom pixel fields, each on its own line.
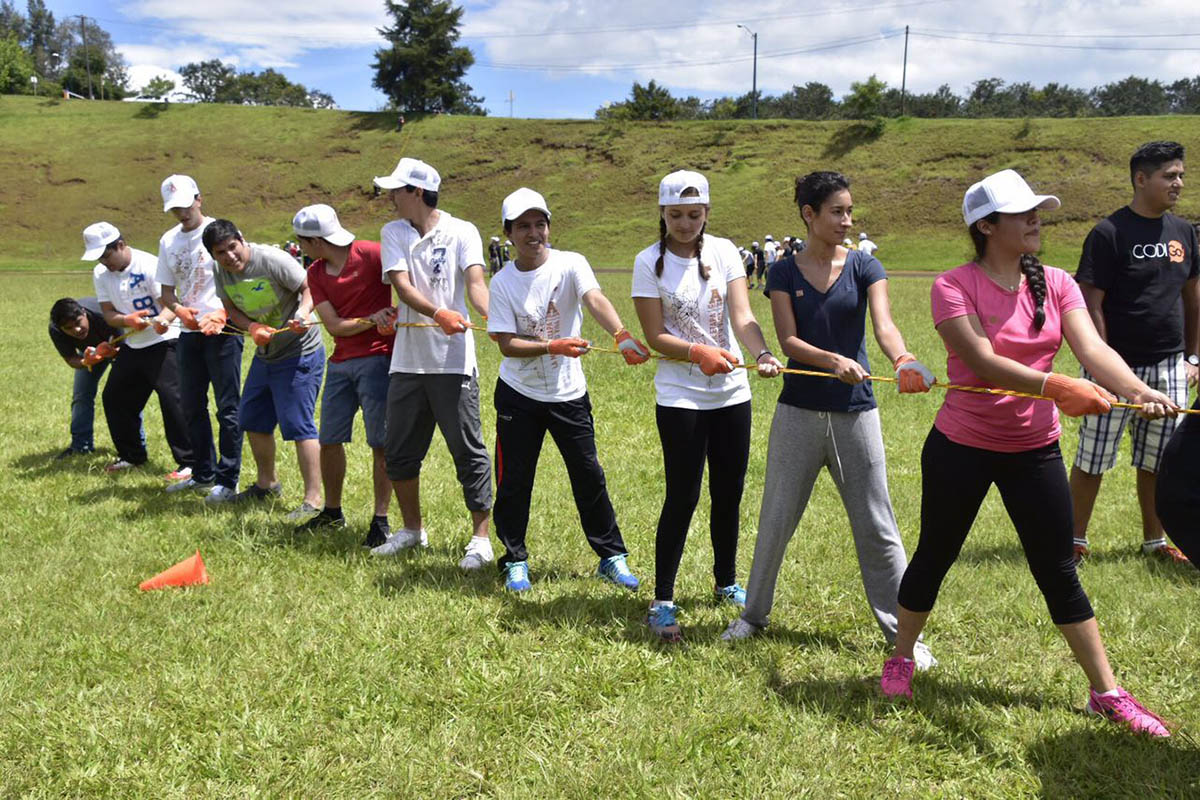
left=487, top=249, right=600, bottom=403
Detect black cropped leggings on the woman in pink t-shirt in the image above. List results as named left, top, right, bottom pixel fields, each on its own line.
left=900, top=428, right=1094, bottom=625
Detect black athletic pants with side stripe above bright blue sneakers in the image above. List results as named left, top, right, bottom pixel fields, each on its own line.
left=492, top=380, right=626, bottom=569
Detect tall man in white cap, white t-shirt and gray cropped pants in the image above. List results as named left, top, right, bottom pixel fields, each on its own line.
left=371, top=158, right=493, bottom=570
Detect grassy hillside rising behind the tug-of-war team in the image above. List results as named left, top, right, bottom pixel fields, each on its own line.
left=0, top=97, right=1200, bottom=269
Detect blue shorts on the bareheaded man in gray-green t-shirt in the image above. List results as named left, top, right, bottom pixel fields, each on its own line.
left=238, top=345, right=325, bottom=441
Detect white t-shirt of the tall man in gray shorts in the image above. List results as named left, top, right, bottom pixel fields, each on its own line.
left=379, top=211, right=484, bottom=375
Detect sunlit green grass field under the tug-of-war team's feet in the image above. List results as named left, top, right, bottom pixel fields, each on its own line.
left=0, top=272, right=1200, bottom=799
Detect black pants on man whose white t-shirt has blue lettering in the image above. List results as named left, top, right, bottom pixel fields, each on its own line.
left=103, top=341, right=192, bottom=467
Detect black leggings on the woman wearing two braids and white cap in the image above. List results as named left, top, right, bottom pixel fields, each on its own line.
left=654, top=401, right=750, bottom=600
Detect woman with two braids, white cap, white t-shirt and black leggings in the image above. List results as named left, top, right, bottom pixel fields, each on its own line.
left=632, top=170, right=781, bottom=642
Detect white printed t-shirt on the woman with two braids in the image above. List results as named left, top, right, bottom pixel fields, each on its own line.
left=632, top=234, right=750, bottom=410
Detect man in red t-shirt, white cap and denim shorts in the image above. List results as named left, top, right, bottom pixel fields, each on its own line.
left=292, top=204, right=396, bottom=547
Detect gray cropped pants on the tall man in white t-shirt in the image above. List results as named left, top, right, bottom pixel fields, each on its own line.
left=385, top=372, right=492, bottom=511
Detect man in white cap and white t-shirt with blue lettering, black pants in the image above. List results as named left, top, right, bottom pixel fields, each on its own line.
left=82, top=222, right=192, bottom=481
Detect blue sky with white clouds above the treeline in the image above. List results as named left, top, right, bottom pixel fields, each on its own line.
left=42, top=0, right=1200, bottom=118
